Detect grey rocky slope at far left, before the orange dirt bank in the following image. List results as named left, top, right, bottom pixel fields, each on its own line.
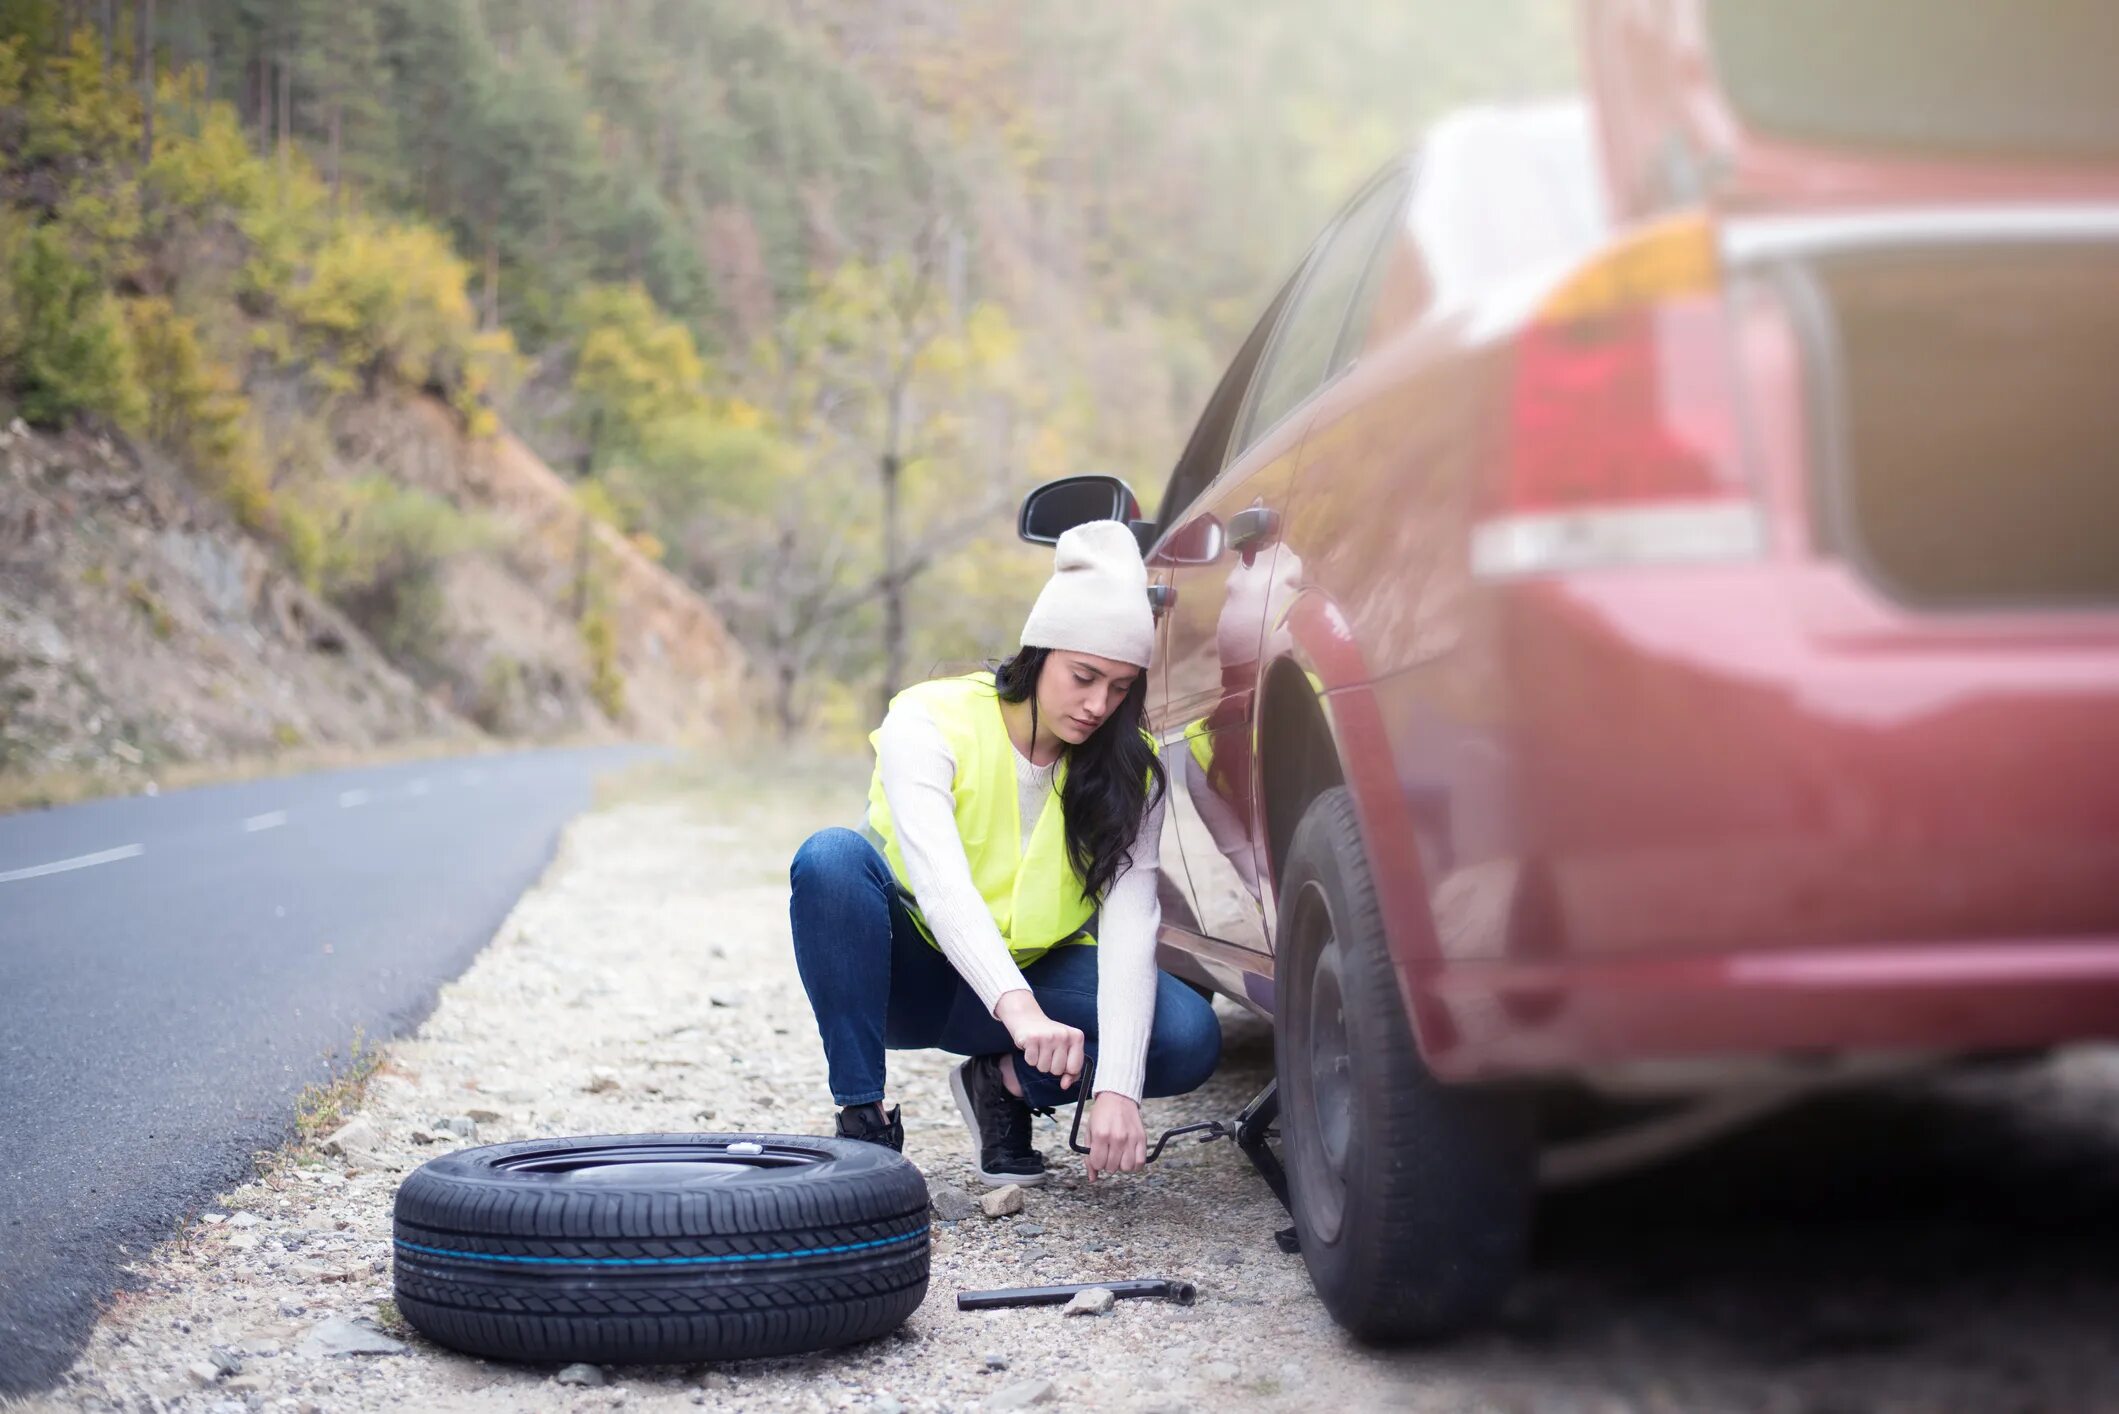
left=0, top=422, right=477, bottom=778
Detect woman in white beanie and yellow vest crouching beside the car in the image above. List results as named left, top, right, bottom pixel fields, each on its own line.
left=788, top=522, right=1221, bottom=1185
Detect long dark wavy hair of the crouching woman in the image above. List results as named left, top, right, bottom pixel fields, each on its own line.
left=994, top=649, right=1170, bottom=901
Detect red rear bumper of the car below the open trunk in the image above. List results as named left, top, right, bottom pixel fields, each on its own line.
left=1356, top=562, right=2119, bottom=1077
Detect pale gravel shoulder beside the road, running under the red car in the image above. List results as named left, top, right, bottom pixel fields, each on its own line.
left=17, top=765, right=2119, bottom=1414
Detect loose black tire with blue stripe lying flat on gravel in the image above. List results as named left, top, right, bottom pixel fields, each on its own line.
left=394, top=1134, right=928, bottom=1363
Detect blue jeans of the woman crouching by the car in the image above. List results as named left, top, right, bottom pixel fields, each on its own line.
left=788, top=829, right=1221, bottom=1107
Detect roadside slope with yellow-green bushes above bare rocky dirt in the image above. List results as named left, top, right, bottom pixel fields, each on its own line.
left=0, top=22, right=744, bottom=799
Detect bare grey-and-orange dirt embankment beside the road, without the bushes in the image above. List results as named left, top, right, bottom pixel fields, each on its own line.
left=0, top=396, right=744, bottom=795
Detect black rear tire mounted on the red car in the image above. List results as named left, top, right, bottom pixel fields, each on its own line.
left=1276, top=789, right=1534, bottom=1344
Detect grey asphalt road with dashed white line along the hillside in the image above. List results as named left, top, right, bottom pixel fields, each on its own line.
left=0, top=748, right=642, bottom=1393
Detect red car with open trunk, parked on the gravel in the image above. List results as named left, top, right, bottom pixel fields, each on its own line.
left=1023, top=0, right=2119, bottom=1340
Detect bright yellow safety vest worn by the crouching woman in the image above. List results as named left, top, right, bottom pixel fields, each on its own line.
left=869, top=672, right=1155, bottom=967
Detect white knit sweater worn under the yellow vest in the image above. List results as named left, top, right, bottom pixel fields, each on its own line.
left=875, top=702, right=1163, bottom=1100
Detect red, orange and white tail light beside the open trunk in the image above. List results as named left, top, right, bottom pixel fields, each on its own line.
left=1473, top=220, right=1763, bottom=575
